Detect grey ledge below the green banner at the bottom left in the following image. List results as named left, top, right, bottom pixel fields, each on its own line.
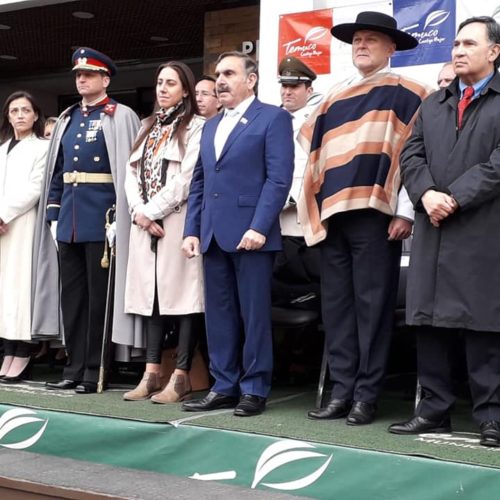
left=0, top=448, right=297, bottom=500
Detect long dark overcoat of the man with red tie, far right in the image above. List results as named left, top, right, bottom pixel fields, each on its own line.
left=401, top=73, right=500, bottom=331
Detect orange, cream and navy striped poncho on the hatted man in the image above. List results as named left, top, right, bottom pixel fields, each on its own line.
left=298, top=72, right=429, bottom=245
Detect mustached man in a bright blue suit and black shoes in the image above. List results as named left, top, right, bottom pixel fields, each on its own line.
left=182, top=52, right=294, bottom=416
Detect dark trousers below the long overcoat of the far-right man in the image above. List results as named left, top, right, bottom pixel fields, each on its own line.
left=416, top=327, right=500, bottom=423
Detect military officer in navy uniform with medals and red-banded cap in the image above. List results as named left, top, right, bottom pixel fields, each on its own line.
left=47, top=47, right=138, bottom=393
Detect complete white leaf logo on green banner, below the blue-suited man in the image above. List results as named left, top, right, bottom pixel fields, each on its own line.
left=252, top=439, right=333, bottom=491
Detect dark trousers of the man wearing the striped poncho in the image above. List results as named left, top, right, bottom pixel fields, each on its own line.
left=321, top=210, right=401, bottom=403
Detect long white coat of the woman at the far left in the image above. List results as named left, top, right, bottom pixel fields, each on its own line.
left=0, top=135, right=49, bottom=341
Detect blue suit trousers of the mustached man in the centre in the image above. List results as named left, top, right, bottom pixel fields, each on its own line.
left=203, top=238, right=274, bottom=397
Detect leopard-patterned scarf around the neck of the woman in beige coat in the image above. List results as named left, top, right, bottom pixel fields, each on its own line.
left=138, top=101, right=185, bottom=202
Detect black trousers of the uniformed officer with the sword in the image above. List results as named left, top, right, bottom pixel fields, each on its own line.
left=59, top=242, right=108, bottom=382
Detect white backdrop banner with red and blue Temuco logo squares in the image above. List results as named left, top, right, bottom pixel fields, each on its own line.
left=259, top=0, right=500, bottom=104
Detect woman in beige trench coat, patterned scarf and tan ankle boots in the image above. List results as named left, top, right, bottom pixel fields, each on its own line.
left=124, top=61, right=204, bottom=403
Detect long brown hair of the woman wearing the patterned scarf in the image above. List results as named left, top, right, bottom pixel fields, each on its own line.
left=132, top=61, right=199, bottom=151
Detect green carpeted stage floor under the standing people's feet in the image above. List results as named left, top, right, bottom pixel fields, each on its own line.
left=0, top=382, right=500, bottom=468
